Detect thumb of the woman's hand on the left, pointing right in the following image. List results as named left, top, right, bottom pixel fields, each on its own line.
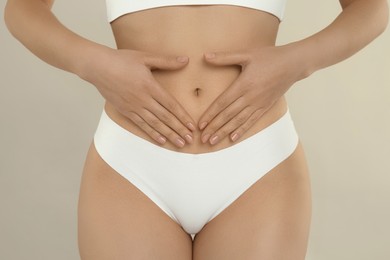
left=144, top=54, right=189, bottom=70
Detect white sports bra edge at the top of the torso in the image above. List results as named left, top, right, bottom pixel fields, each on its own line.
left=106, top=0, right=287, bottom=22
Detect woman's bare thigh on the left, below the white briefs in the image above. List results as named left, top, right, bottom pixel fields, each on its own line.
left=78, top=144, right=192, bottom=260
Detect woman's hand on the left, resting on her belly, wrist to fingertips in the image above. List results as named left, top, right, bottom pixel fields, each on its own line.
left=80, top=47, right=195, bottom=147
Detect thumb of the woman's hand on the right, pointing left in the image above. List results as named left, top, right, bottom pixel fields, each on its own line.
left=204, top=51, right=249, bottom=66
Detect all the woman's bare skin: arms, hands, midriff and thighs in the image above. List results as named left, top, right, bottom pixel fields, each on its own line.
left=5, top=0, right=387, bottom=260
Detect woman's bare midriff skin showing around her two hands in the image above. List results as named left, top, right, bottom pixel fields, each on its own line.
left=105, top=5, right=287, bottom=153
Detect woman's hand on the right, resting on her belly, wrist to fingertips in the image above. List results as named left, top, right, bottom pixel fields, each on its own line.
left=199, top=45, right=305, bottom=145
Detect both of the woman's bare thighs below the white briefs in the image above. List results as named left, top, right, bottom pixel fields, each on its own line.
left=79, top=141, right=311, bottom=260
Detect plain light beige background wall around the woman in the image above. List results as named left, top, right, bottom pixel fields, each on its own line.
left=0, top=0, right=390, bottom=260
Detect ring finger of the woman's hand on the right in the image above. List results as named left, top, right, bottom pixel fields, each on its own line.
left=206, top=106, right=254, bottom=145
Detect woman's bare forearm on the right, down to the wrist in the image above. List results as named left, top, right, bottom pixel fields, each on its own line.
left=291, top=0, right=388, bottom=76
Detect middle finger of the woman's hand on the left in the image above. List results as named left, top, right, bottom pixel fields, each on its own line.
left=148, top=100, right=193, bottom=143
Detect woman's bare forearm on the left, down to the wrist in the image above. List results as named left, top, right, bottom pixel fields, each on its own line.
left=4, top=0, right=108, bottom=75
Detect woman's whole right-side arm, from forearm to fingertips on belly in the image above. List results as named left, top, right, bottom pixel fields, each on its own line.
left=199, top=0, right=388, bottom=144
